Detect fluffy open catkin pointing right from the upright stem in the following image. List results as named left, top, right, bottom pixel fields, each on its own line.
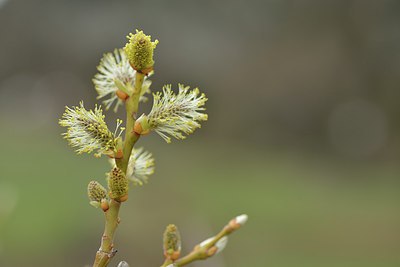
left=148, top=84, right=208, bottom=143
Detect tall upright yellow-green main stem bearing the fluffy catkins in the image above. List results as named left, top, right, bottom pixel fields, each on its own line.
left=93, top=72, right=144, bottom=267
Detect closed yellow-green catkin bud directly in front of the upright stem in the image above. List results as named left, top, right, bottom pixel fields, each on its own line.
left=107, top=167, right=128, bottom=202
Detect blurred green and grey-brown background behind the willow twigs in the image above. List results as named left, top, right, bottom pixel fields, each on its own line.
left=0, top=0, right=400, bottom=267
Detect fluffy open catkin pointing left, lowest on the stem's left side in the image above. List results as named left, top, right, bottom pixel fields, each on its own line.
left=59, top=102, right=121, bottom=157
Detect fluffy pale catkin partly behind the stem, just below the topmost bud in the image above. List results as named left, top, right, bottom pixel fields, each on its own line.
left=92, top=49, right=151, bottom=112
